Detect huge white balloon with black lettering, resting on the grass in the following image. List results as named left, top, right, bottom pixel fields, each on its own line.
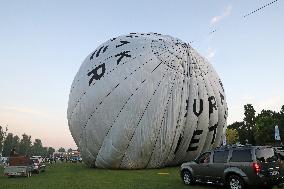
left=67, top=33, right=227, bottom=169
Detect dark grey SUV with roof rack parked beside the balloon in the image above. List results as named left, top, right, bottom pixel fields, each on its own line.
left=181, top=146, right=284, bottom=189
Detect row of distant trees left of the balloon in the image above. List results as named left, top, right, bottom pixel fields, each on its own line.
left=0, top=125, right=55, bottom=157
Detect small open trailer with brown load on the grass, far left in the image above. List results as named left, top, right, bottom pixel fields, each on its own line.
left=4, top=156, right=32, bottom=177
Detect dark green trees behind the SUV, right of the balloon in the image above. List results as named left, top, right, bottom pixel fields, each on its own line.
left=226, top=104, right=284, bottom=145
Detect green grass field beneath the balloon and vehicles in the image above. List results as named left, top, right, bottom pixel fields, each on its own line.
left=0, top=163, right=218, bottom=189
